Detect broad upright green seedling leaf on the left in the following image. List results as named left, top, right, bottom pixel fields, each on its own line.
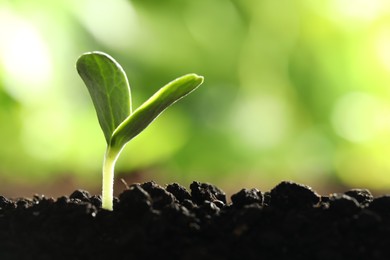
left=76, top=52, right=131, bottom=144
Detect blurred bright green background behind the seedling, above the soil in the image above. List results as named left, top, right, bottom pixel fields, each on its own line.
left=0, top=0, right=390, bottom=196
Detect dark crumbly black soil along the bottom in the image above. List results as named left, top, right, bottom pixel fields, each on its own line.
left=0, top=182, right=390, bottom=260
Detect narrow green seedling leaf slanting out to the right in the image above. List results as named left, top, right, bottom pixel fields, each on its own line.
left=110, top=74, right=203, bottom=150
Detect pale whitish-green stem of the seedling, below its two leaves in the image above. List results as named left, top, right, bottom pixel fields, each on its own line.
left=102, top=145, right=121, bottom=210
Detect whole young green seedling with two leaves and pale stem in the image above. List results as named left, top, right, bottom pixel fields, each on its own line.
left=77, top=52, right=203, bottom=210
